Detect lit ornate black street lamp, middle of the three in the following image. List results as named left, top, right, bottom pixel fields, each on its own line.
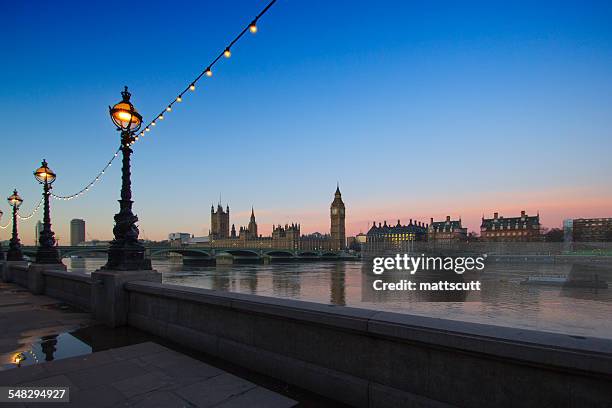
left=34, top=160, right=62, bottom=264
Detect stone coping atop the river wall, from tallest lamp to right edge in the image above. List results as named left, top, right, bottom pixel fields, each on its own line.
left=125, top=281, right=612, bottom=375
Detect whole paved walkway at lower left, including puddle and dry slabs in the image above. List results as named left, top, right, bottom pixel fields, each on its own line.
left=0, top=283, right=296, bottom=408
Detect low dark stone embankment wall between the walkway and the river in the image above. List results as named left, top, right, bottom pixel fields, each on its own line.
left=5, top=265, right=612, bottom=408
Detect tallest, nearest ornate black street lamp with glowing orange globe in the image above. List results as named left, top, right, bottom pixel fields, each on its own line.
left=102, top=86, right=151, bottom=271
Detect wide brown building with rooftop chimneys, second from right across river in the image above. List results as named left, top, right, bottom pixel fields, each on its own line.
left=480, top=211, right=542, bottom=242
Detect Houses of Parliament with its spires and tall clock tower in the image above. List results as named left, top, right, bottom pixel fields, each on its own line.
left=208, top=186, right=346, bottom=251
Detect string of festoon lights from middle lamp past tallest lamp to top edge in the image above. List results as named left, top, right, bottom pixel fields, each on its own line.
left=51, top=0, right=276, bottom=200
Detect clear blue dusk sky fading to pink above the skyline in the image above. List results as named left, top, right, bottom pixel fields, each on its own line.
left=0, top=0, right=612, bottom=244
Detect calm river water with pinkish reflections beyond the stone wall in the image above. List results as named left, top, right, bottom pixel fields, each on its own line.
left=64, top=258, right=612, bottom=339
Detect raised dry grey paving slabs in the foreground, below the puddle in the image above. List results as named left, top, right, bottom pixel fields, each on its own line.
left=0, top=342, right=296, bottom=408
